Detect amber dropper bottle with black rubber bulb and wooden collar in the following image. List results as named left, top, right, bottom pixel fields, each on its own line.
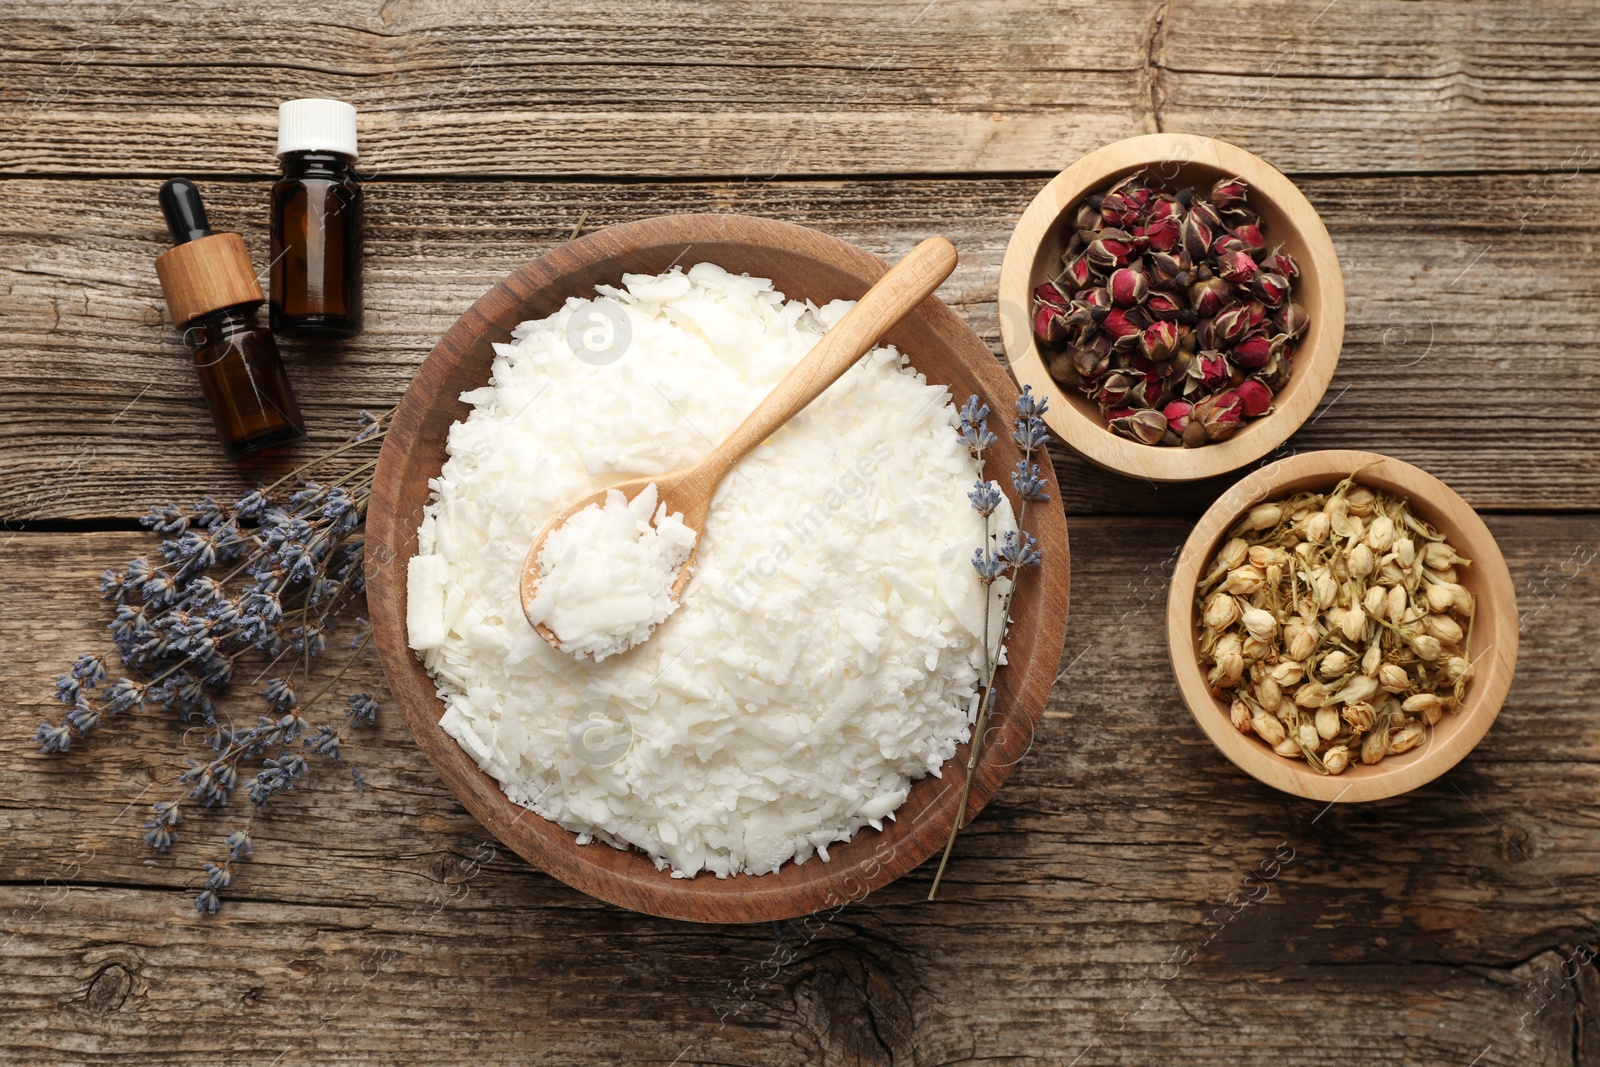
left=155, top=178, right=306, bottom=459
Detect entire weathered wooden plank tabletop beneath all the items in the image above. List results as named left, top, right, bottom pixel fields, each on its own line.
left=0, top=0, right=1600, bottom=1067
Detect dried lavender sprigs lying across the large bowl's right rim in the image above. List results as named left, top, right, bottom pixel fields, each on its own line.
left=928, top=386, right=1050, bottom=901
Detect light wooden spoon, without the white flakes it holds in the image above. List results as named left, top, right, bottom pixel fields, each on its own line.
left=522, top=237, right=955, bottom=648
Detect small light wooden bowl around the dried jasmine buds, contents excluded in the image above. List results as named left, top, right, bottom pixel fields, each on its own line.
left=1166, top=451, right=1518, bottom=801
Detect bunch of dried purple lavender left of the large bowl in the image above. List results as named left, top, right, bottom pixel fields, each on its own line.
left=34, top=411, right=389, bottom=915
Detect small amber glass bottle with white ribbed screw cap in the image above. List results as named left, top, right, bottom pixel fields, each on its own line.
left=269, top=99, right=363, bottom=338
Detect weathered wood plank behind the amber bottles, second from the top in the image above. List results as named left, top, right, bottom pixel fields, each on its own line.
left=0, top=174, right=1600, bottom=526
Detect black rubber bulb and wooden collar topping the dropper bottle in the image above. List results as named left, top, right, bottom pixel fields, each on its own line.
left=155, top=178, right=267, bottom=326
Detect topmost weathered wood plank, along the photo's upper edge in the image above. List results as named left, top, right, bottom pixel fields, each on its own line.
left=0, top=0, right=1600, bottom=176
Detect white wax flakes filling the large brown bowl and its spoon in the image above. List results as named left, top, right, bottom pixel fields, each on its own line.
left=406, top=262, right=1010, bottom=878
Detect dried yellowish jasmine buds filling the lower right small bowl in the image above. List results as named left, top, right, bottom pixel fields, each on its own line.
left=1195, top=472, right=1474, bottom=774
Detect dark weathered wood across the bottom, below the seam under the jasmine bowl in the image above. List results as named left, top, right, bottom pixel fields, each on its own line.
left=0, top=517, right=1600, bottom=1067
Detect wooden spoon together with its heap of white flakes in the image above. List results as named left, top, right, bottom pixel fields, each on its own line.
left=522, top=237, right=957, bottom=662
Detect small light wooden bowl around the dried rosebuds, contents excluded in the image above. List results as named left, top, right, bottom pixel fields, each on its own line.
left=998, top=133, right=1344, bottom=482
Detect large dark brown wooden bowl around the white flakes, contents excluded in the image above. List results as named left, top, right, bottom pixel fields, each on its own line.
left=366, top=214, right=1070, bottom=923
